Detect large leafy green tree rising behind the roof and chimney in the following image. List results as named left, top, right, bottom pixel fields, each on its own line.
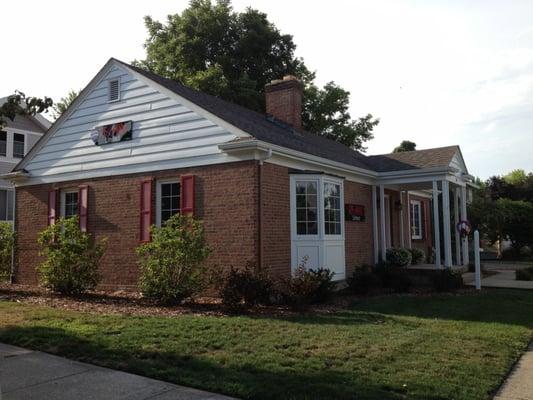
left=134, top=0, right=379, bottom=151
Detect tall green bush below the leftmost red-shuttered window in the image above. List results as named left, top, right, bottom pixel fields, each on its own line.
left=37, top=218, right=106, bottom=295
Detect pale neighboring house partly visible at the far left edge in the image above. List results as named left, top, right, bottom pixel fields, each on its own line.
left=0, top=97, right=50, bottom=222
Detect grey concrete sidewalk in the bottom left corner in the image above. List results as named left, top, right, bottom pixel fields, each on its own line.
left=0, top=343, right=237, bottom=400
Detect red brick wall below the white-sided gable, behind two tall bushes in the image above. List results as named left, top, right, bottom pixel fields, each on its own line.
left=15, top=161, right=258, bottom=288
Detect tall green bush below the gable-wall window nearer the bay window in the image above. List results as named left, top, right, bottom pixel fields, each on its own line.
left=137, top=214, right=210, bottom=304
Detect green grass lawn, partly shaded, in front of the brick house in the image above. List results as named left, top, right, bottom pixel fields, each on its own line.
left=0, top=290, right=533, bottom=400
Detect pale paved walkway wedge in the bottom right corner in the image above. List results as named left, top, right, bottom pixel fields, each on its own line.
left=494, top=344, right=533, bottom=400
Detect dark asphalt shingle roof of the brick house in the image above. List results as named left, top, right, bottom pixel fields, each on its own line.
left=116, top=60, right=458, bottom=172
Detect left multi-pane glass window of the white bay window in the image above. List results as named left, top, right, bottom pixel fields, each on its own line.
left=296, top=181, right=318, bottom=235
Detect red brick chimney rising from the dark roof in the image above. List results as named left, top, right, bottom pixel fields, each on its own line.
left=265, top=75, right=303, bottom=129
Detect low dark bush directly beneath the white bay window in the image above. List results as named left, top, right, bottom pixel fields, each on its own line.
left=279, top=264, right=336, bottom=309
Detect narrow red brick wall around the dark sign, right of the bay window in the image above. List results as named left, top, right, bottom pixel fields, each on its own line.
left=344, top=181, right=374, bottom=278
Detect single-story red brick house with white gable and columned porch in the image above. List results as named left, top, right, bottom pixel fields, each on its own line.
left=3, top=59, right=471, bottom=288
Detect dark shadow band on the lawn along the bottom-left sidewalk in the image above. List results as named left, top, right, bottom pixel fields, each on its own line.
left=0, top=326, right=454, bottom=400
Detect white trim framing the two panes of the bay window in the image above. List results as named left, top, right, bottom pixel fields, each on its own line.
left=290, top=174, right=344, bottom=241
